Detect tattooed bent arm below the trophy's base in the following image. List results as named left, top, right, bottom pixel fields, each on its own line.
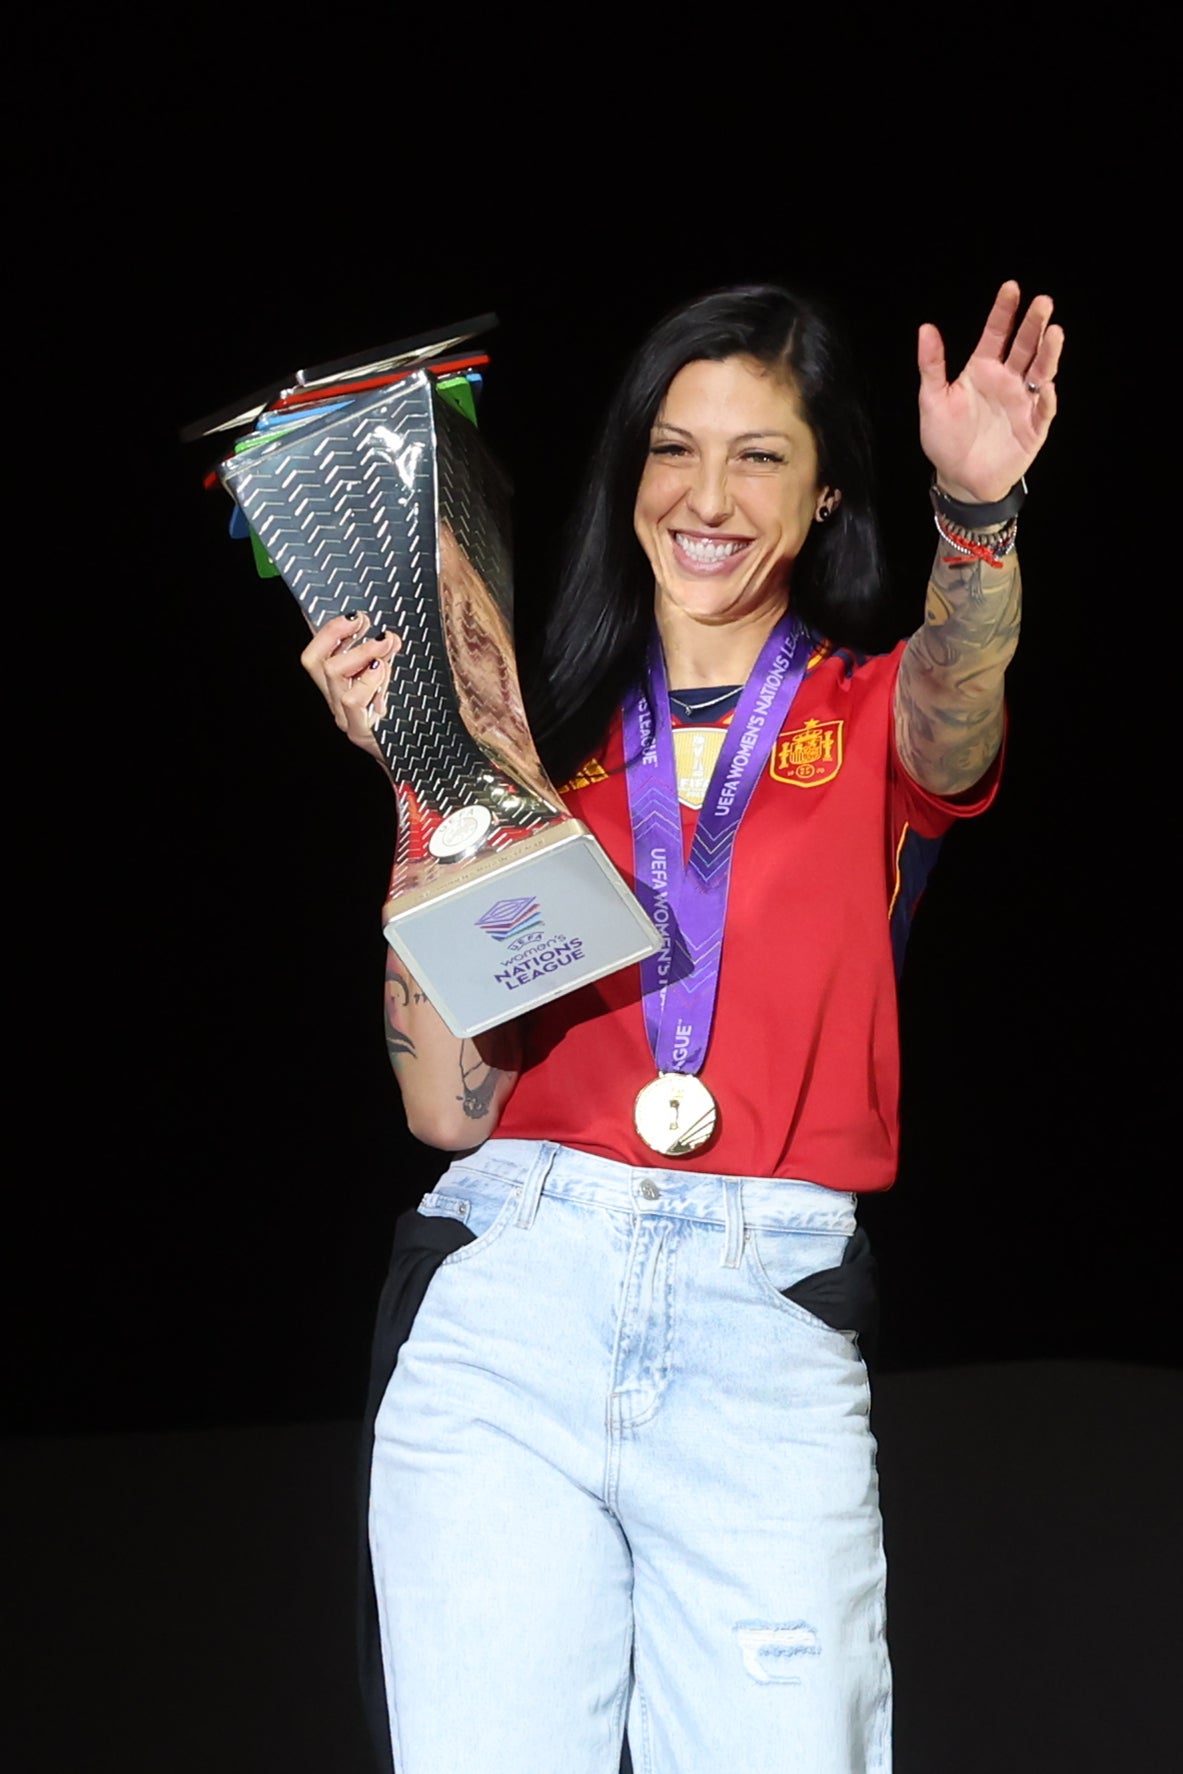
left=385, top=949, right=521, bottom=1151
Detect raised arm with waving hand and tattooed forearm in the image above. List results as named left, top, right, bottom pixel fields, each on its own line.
left=896, top=284, right=1064, bottom=795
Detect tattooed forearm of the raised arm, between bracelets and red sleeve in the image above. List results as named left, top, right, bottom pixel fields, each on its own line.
left=896, top=550, right=1022, bottom=795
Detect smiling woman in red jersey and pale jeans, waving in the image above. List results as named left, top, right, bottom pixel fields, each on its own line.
left=305, top=284, right=1062, bottom=1774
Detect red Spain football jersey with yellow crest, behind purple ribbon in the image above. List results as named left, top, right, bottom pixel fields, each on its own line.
left=497, top=642, right=997, bottom=1190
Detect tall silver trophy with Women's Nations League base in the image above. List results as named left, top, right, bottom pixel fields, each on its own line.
left=186, top=326, right=662, bottom=1036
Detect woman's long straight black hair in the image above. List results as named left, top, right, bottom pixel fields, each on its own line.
left=529, top=284, right=881, bottom=782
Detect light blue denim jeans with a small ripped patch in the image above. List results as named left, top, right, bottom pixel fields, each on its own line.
left=371, top=1141, right=890, bottom=1774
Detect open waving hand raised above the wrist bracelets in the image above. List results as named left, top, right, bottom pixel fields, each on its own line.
left=917, top=282, right=1064, bottom=506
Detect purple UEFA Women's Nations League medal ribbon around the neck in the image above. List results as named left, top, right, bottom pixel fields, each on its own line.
left=623, top=610, right=811, bottom=1071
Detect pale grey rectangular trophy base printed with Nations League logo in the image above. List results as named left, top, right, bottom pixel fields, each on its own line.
left=383, top=820, right=662, bottom=1036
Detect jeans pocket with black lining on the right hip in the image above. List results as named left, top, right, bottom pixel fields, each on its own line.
left=748, top=1226, right=878, bottom=1338
